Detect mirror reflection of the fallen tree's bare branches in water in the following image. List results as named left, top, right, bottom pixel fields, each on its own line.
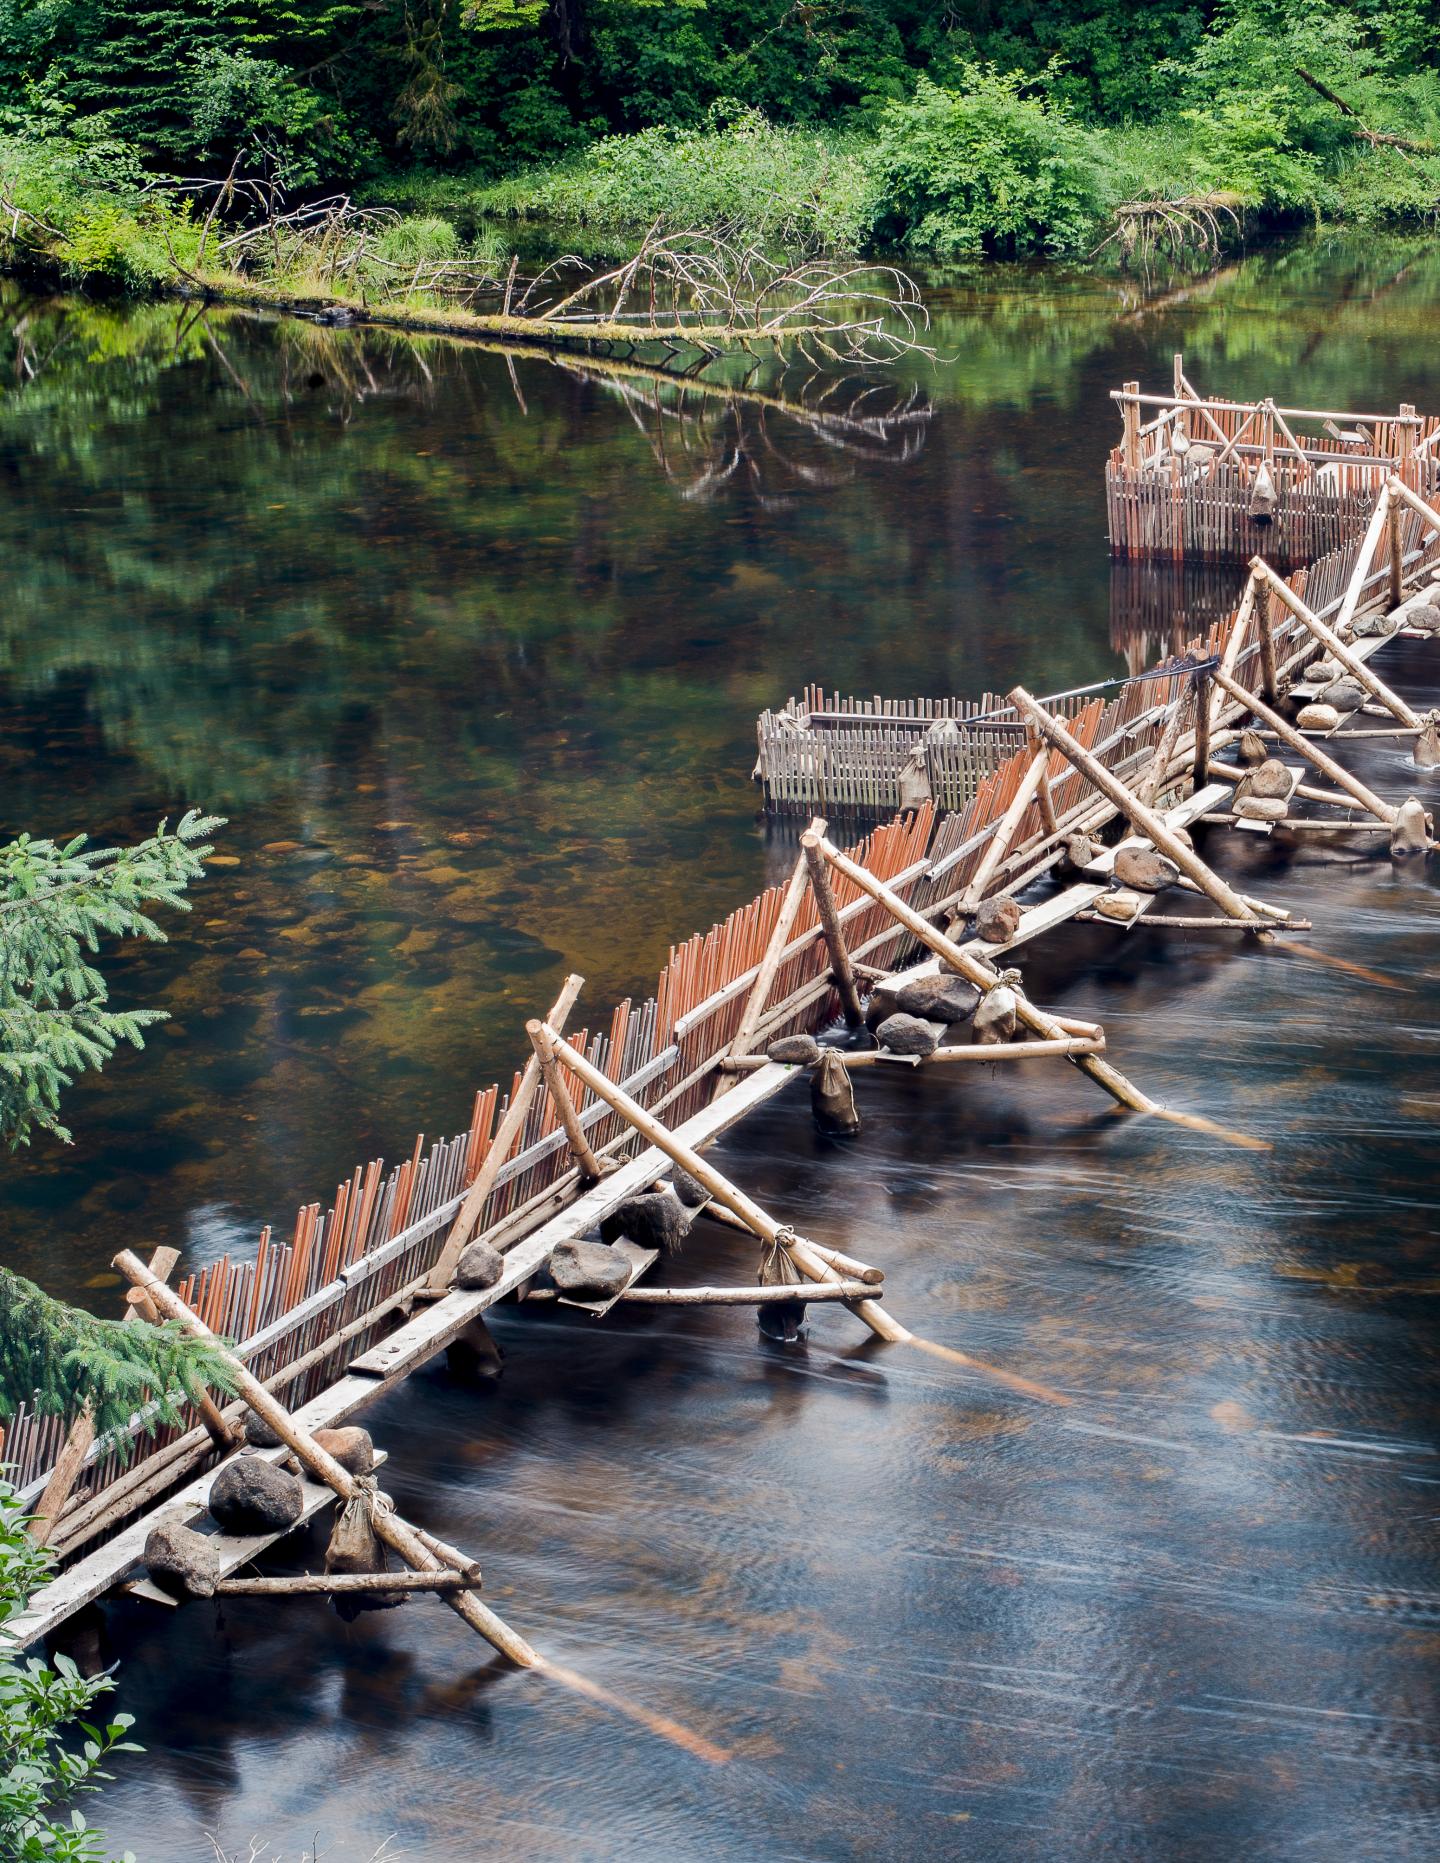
left=559, top=360, right=933, bottom=507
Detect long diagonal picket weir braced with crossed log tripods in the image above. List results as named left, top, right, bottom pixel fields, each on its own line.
left=6, top=422, right=1440, bottom=1759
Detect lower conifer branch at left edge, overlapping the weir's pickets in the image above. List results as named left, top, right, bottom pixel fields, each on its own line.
left=0, top=1269, right=233, bottom=1436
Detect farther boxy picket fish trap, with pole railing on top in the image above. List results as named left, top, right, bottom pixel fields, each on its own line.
left=1105, top=356, right=1440, bottom=564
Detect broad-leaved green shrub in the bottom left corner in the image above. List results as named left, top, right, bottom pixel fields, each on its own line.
left=0, top=1482, right=137, bottom=1863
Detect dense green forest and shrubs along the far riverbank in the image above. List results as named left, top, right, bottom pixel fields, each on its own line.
left=0, top=0, right=1440, bottom=285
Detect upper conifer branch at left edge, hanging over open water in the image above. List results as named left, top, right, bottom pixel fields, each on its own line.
left=0, top=809, right=222, bottom=1146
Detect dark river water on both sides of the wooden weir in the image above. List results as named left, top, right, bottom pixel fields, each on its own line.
left=0, top=240, right=1440, bottom=1863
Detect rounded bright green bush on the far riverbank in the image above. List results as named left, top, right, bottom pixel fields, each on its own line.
left=872, top=65, right=1103, bottom=253
